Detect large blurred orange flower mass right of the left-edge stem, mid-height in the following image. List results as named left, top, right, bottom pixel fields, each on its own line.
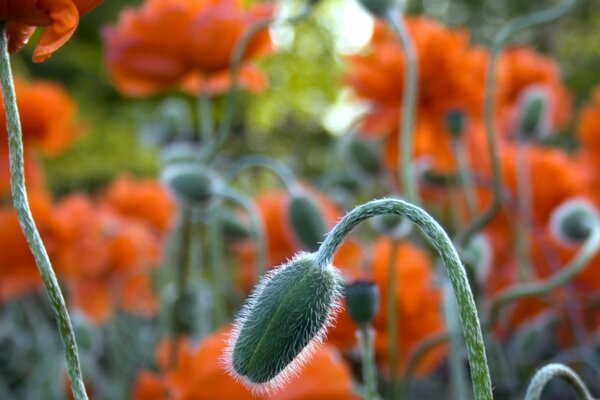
left=52, top=195, right=160, bottom=323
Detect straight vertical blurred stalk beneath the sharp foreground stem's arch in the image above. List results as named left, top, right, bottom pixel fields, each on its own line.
left=386, top=239, right=401, bottom=400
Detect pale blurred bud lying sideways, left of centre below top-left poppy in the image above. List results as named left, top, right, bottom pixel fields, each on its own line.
left=162, top=163, right=217, bottom=204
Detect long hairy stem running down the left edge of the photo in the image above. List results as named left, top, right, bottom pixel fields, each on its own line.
left=0, top=23, right=88, bottom=400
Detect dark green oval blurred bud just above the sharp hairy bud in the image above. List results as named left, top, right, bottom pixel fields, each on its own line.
left=288, top=194, right=327, bottom=251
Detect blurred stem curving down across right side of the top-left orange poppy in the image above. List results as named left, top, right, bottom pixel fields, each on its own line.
left=200, top=4, right=312, bottom=162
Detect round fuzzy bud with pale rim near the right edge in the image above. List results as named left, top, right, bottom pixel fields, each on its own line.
left=550, top=198, right=598, bottom=245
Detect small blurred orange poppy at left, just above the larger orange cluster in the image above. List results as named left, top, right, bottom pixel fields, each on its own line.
left=104, top=176, right=175, bottom=232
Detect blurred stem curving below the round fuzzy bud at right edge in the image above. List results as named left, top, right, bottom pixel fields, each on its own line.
left=486, top=225, right=600, bottom=328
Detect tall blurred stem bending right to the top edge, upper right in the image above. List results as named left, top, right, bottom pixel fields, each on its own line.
left=456, top=0, right=578, bottom=248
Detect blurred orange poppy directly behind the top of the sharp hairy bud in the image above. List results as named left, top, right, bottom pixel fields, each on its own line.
left=235, top=190, right=360, bottom=289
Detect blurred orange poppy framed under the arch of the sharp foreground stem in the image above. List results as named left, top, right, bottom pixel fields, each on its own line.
left=328, top=238, right=446, bottom=375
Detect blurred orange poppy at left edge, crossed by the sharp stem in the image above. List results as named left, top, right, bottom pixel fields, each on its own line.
left=0, top=79, right=79, bottom=154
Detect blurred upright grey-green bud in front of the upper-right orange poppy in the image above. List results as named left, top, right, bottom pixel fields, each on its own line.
left=517, top=85, right=550, bottom=140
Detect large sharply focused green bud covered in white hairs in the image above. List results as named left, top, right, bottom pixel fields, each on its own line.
left=225, top=253, right=341, bottom=393
